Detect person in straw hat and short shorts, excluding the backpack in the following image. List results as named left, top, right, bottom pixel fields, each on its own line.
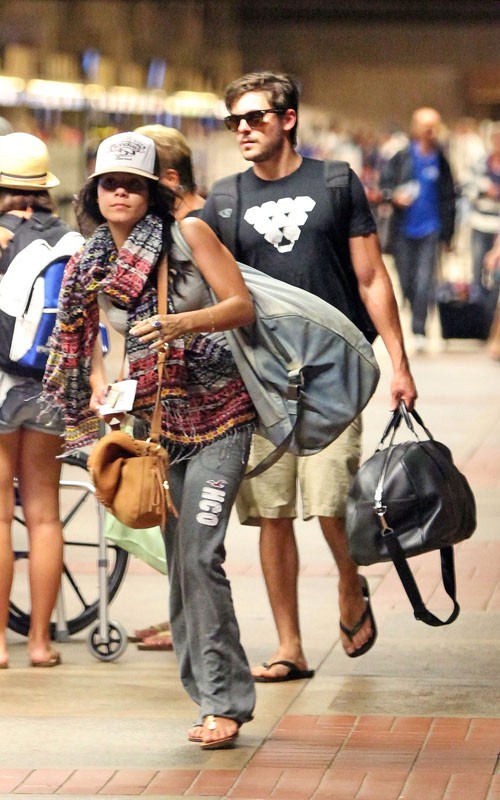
left=0, top=133, right=81, bottom=669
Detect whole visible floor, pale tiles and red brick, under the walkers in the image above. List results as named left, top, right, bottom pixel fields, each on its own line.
left=0, top=330, right=500, bottom=800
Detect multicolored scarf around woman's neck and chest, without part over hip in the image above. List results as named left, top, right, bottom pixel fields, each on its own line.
left=41, top=214, right=163, bottom=449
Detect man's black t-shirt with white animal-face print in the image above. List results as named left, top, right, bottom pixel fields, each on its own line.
left=202, top=158, right=376, bottom=318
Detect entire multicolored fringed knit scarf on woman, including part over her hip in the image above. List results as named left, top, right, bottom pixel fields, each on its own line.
left=41, top=215, right=256, bottom=456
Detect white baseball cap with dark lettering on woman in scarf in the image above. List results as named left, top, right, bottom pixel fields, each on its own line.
left=89, top=131, right=159, bottom=181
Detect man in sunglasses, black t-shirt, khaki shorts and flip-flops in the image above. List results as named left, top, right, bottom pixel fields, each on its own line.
left=202, top=72, right=417, bottom=682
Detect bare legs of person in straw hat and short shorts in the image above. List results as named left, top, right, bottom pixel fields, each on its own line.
left=0, top=430, right=62, bottom=662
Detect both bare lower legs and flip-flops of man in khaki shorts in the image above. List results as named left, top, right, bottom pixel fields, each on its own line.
left=252, top=517, right=372, bottom=677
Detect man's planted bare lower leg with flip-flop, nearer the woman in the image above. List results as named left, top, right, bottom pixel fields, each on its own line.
left=252, top=519, right=307, bottom=678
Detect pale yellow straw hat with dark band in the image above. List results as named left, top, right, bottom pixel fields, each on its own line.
left=0, top=133, right=59, bottom=191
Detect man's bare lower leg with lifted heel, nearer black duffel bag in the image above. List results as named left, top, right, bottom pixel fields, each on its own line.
left=319, top=517, right=373, bottom=655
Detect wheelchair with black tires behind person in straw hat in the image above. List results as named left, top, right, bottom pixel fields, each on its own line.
left=8, top=452, right=129, bottom=661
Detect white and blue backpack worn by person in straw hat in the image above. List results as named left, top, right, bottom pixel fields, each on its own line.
left=0, top=231, right=84, bottom=379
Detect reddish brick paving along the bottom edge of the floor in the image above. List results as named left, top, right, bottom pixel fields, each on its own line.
left=0, top=715, right=500, bottom=800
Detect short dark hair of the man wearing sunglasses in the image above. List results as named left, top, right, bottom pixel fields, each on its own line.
left=224, top=71, right=300, bottom=147
